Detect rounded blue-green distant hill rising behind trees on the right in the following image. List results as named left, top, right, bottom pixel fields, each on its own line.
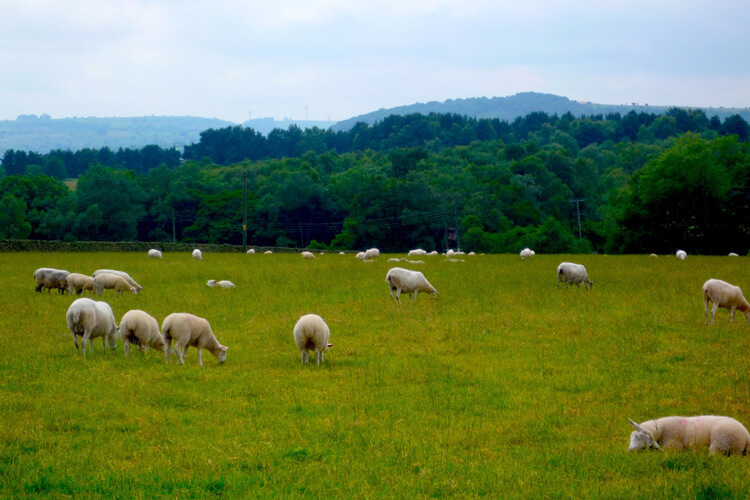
left=332, top=92, right=750, bottom=130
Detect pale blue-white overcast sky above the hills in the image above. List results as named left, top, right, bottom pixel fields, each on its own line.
left=0, top=0, right=750, bottom=123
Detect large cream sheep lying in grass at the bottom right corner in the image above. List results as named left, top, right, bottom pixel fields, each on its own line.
left=628, top=415, right=750, bottom=455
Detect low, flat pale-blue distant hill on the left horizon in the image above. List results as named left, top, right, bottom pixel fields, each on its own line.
left=0, top=115, right=235, bottom=155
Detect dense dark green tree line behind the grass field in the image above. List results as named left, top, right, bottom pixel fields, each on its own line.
left=0, top=108, right=750, bottom=254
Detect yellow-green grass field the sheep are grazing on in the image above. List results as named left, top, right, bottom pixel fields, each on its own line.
left=0, top=253, right=750, bottom=498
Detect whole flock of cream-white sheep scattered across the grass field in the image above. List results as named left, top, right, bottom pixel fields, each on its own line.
left=34, top=244, right=750, bottom=455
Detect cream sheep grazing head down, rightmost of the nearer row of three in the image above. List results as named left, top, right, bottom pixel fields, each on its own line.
left=161, top=313, right=228, bottom=366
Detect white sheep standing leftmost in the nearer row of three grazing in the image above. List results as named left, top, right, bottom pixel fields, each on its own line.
left=66, top=298, right=119, bottom=357
